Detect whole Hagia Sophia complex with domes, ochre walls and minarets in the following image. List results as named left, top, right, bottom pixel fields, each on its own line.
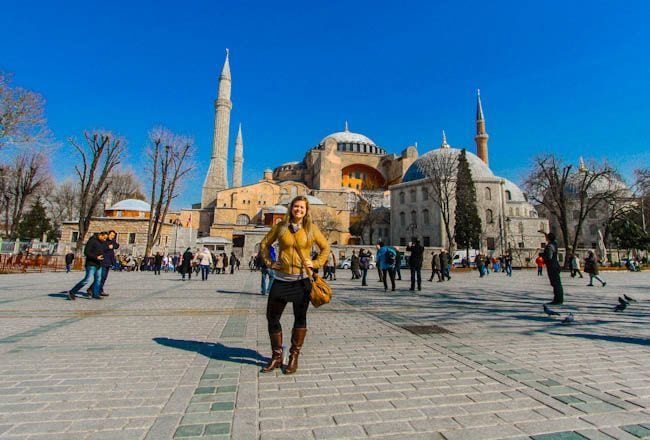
left=191, top=51, right=548, bottom=259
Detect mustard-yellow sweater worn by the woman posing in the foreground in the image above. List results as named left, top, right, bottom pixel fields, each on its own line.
left=260, top=223, right=330, bottom=274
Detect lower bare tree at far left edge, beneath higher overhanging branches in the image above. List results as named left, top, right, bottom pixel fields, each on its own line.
left=0, top=151, right=50, bottom=238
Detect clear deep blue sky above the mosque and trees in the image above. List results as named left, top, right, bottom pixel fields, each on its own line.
left=0, top=0, right=650, bottom=206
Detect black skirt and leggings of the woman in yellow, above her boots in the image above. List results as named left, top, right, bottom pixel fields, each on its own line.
left=266, top=279, right=309, bottom=335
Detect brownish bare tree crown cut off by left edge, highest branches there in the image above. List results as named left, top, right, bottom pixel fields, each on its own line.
left=0, top=72, right=51, bottom=150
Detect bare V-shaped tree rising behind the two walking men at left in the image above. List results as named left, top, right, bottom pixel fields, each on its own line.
left=69, top=131, right=126, bottom=253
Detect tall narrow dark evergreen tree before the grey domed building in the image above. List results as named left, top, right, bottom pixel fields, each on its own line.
left=454, top=149, right=481, bottom=254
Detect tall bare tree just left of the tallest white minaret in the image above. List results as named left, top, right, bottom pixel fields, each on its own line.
left=145, top=127, right=194, bottom=255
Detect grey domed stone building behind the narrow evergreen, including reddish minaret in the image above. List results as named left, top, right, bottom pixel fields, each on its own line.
left=390, top=95, right=549, bottom=258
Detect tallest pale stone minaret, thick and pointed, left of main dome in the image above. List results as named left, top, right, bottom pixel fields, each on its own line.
left=201, top=49, right=232, bottom=208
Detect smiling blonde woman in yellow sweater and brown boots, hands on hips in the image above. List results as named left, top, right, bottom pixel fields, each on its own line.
left=260, top=196, right=330, bottom=374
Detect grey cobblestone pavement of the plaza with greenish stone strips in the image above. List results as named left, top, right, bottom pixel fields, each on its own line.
left=0, top=271, right=650, bottom=440
